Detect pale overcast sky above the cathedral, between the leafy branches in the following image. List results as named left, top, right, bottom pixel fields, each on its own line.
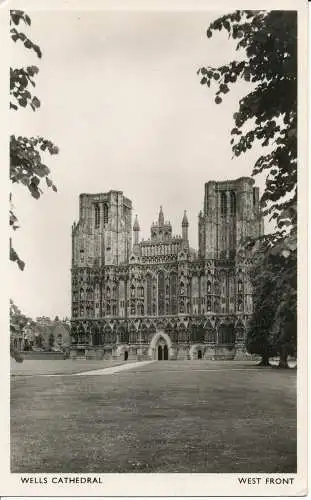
left=10, top=11, right=270, bottom=317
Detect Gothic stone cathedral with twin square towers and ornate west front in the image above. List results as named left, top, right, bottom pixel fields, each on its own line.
left=71, top=177, right=263, bottom=361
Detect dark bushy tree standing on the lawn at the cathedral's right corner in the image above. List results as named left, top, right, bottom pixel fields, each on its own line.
left=247, top=236, right=297, bottom=368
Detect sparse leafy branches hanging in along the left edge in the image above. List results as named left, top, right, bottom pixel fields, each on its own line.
left=9, top=10, right=58, bottom=270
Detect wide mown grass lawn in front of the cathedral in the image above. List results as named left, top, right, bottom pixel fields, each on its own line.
left=11, top=361, right=296, bottom=473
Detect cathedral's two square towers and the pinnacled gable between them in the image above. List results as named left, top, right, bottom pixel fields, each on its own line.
left=72, top=177, right=264, bottom=268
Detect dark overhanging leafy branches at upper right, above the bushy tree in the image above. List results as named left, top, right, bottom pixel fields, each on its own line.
left=198, top=11, right=297, bottom=235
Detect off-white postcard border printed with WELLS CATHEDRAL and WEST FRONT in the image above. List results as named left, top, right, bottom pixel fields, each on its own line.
left=0, top=0, right=308, bottom=497
